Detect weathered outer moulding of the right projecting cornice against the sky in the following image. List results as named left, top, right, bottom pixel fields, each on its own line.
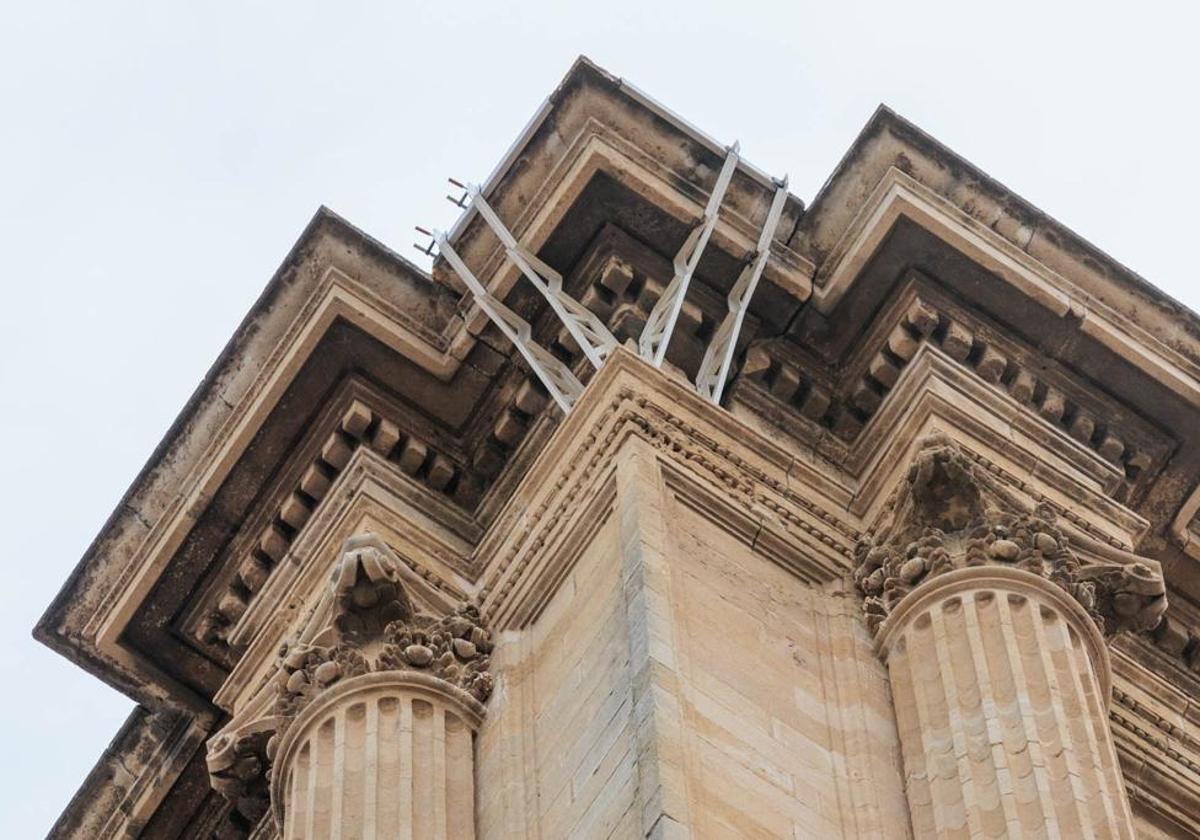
left=792, top=114, right=1200, bottom=391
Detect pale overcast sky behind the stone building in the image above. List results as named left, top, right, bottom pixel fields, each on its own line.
left=0, top=0, right=1200, bottom=838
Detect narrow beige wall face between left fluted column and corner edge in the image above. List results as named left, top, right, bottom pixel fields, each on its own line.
left=479, top=508, right=637, bottom=840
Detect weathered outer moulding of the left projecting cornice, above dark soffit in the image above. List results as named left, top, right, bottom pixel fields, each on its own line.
left=36, top=255, right=468, bottom=704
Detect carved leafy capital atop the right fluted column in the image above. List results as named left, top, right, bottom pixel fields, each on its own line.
left=854, top=433, right=1166, bottom=635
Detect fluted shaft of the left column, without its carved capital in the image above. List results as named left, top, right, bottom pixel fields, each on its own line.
left=271, top=671, right=484, bottom=840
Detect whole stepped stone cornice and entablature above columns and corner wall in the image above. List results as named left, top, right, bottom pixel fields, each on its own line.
left=36, top=59, right=1200, bottom=830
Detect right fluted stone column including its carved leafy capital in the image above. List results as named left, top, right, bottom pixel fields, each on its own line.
left=856, top=436, right=1166, bottom=839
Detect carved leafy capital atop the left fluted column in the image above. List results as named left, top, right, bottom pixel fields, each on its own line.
left=208, top=535, right=493, bottom=838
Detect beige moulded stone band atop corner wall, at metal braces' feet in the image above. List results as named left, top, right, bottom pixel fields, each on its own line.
left=475, top=350, right=858, bottom=629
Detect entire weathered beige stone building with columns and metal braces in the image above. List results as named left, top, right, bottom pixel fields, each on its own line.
left=36, top=59, right=1200, bottom=840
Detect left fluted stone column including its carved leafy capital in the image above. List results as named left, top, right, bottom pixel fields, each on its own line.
left=208, top=536, right=492, bottom=840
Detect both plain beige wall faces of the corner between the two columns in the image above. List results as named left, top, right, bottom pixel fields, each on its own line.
left=476, top=440, right=910, bottom=840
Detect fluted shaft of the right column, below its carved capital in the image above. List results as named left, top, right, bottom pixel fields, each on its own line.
left=878, top=565, right=1134, bottom=838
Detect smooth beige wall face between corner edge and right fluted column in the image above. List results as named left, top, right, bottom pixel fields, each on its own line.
left=667, top=482, right=908, bottom=839
